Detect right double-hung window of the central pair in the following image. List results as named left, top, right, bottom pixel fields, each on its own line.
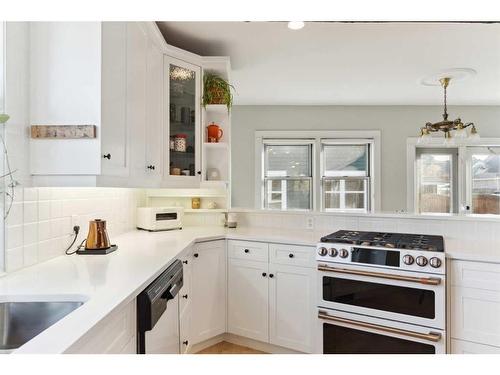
left=321, top=139, right=372, bottom=212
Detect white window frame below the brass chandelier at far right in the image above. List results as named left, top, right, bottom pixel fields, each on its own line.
left=406, top=137, right=500, bottom=217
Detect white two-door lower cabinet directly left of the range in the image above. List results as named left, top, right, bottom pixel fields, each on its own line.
left=227, top=241, right=316, bottom=353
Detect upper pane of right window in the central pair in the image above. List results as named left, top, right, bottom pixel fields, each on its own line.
left=323, top=145, right=369, bottom=176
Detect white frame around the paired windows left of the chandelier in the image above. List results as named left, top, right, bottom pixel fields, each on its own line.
left=255, top=130, right=381, bottom=212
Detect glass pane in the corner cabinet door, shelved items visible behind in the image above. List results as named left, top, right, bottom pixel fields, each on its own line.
left=169, top=64, right=196, bottom=176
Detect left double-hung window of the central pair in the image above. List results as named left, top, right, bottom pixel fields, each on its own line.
left=263, top=139, right=313, bottom=210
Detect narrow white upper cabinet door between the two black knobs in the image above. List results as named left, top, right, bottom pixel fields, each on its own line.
left=127, top=22, right=148, bottom=186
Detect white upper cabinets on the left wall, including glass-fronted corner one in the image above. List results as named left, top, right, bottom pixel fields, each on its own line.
left=30, top=22, right=229, bottom=188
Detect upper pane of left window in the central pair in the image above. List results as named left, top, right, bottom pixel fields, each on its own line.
left=264, top=145, right=312, bottom=177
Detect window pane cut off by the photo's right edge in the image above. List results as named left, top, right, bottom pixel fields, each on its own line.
left=472, top=148, right=500, bottom=215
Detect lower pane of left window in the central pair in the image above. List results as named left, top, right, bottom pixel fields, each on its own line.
left=264, top=179, right=311, bottom=210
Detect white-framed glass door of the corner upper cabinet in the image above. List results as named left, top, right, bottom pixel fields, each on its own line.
left=165, top=57, right=200, bottom=177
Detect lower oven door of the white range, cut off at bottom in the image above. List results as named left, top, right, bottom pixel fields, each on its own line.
left=318, top=309, right=446, bottom=354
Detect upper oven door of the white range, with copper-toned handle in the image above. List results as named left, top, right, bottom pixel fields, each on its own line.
left=318, top=264, right=446, bottom=329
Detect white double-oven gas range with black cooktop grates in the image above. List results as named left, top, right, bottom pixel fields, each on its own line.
left=316, top=230, right=446, bottom=354
